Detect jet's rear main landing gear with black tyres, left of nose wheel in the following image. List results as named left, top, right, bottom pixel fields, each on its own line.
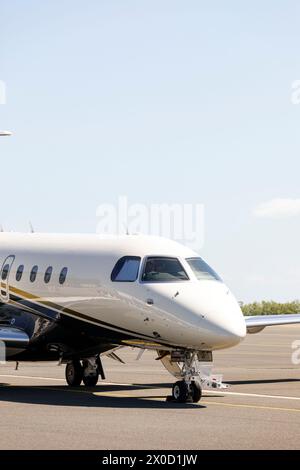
left=66, top=356, right=105, bottom=387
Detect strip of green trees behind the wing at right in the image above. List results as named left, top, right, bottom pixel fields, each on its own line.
left=240, top=300, right=300, bottom=316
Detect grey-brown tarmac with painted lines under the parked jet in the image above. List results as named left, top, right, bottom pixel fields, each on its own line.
left=0, top=326, right=300, bottom=450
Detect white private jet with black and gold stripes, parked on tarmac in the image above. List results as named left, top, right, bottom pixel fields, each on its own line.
left=0, top=232, right=300, bottom=403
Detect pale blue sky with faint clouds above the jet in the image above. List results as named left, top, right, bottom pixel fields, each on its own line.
left=0, top=0, right=300, bottom=301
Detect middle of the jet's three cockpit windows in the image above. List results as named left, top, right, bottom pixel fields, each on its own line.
left=142, top=256, right=189, bottom=282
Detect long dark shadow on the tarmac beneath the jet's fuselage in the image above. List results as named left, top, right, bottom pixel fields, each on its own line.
left=0, top=383, right=206, bottom=410
